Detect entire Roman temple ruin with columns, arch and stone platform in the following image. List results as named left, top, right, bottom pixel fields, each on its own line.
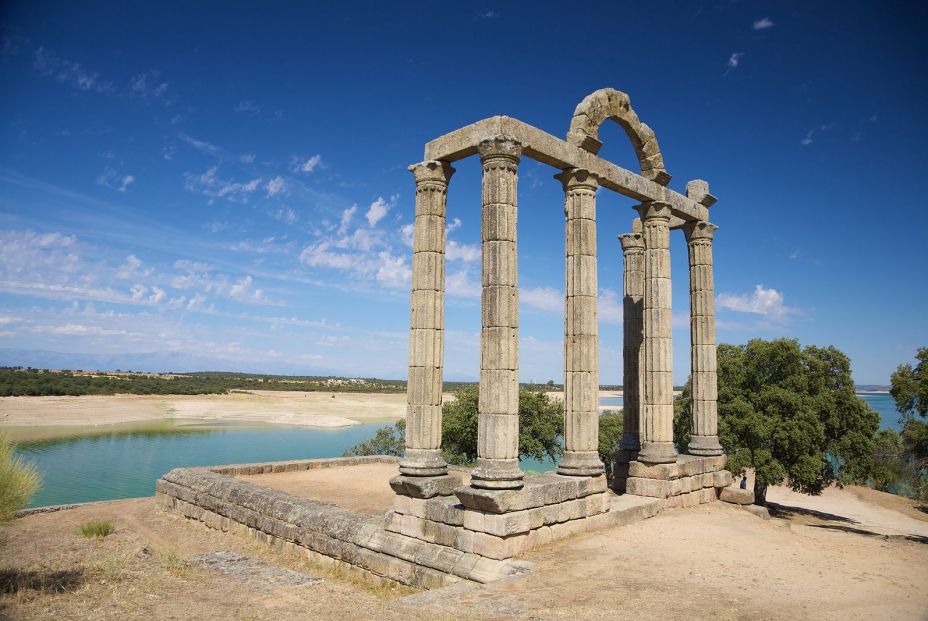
left=157, top=89, right=753, bottom=587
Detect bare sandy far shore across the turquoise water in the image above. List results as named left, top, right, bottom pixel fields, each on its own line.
left=0, top=390, right=622, bottom=435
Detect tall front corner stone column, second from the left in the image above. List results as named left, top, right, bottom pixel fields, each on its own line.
left=471, top=136, right=522, bottom=489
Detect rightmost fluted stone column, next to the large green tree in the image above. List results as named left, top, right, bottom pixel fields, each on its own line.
left=683, top=222, right=722, bottom=455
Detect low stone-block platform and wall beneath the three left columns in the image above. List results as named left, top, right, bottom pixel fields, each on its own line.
left=156, top=457, right=665, bottom=588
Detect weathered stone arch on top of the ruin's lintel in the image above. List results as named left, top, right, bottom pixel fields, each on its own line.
left=567, top=88, right=670, bottom=185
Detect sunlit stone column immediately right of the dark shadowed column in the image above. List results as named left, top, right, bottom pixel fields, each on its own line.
left=638, top=201, right=677, bottom=464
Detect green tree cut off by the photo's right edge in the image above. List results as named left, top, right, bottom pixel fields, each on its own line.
left=889, top=347, right=928, bottom=500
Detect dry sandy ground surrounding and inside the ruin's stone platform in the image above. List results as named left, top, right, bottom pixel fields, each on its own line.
left=0, top=465, right=928, bottom=621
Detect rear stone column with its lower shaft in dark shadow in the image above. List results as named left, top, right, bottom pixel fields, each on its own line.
left=619, top=218, right=644, bottom=453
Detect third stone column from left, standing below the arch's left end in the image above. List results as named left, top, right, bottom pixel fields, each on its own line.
left=556, top=168, right=604, bottom=476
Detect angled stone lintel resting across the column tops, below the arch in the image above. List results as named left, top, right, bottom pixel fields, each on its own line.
left=425, top=116, right=709, bottom=223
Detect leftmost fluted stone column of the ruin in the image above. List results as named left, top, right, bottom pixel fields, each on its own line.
left=400, top=160, right=454, bottom=476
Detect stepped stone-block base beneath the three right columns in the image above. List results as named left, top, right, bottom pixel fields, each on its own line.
left=613, top=452, right=732, bottom=507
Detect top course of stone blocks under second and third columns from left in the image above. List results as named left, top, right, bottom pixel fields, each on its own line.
left=454, top=473, right=607, bottom=514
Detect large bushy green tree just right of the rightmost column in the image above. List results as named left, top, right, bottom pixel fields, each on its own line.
left=674, top=339, right=880, bottom=504
